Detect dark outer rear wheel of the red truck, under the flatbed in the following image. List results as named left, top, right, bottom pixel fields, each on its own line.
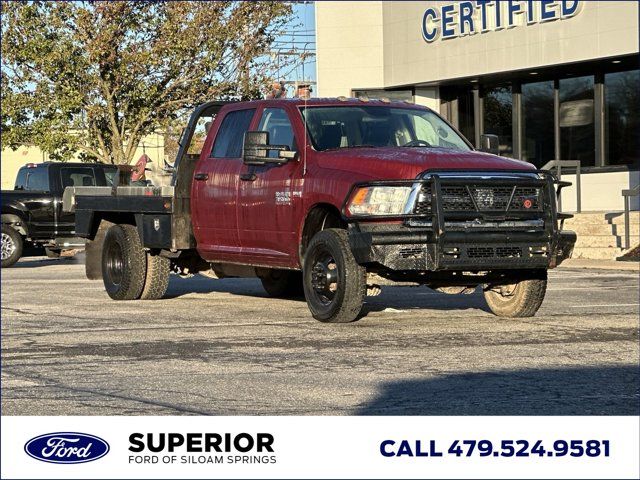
left=102, top=225, right=147, bottom=300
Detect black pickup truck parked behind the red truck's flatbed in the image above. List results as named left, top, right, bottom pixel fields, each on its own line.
left=1, top=162, right=117, bottom=268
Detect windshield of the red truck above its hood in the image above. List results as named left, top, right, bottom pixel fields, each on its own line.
left=302, top=105, right=471, bottom=151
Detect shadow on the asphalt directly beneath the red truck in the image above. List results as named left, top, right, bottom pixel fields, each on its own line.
left=164, top=275, right=490, bottom=319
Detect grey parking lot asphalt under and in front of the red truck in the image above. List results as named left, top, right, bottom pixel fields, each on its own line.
left=2, top=257, right=640, bottom=415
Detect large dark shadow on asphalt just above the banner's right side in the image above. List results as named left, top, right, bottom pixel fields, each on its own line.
left=354, top=365, right=640, bottom=415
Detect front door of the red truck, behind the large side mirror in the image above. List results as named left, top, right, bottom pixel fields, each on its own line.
left=238, top=108, right=302, bottom=267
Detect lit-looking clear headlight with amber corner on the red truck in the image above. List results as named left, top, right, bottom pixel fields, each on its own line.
left=347, top=186, right=411, bottom=216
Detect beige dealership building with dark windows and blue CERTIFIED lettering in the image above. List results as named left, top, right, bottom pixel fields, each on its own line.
left=316, top=0, right=640, bottom=212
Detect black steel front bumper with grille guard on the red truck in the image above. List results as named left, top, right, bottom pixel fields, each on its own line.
left=343, top=172, right=576, bottom=271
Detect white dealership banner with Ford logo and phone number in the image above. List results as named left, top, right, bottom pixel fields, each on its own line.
left=1, top=417, right=640, bottom=479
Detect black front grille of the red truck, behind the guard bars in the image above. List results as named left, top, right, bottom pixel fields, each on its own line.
left=413, top=184, right=542, bottom=216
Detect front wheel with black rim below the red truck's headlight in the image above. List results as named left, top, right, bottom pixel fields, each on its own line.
left=303, top=228, right=367, bottom=323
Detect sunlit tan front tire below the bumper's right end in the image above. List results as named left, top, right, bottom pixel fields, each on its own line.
left=484, top=270, right=547, bottom=318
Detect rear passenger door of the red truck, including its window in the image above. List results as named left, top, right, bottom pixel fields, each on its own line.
left=191, top=109, right=255, bottom=261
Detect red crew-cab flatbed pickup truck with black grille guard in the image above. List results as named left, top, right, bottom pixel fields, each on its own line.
left=65, top=98, right=576, bottom=322
